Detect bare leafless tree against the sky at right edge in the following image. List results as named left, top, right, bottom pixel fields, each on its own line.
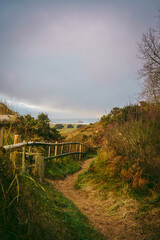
left=138, top=16, right=160, bottom=102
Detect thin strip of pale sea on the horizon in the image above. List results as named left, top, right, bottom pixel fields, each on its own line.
left=51, top=118, right=100, bottom=124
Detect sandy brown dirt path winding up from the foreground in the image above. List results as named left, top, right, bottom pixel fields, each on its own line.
left=47, top=159, right=145, bottom=240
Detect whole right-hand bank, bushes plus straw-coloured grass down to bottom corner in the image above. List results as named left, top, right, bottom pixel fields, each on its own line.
left=75, top=102, right=160, bottom=240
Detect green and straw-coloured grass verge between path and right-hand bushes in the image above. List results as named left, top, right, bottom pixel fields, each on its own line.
left=75, top=151, right=160, bottom=240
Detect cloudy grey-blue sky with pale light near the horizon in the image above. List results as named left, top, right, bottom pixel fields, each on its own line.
left=0, top=0, right=160, bottom=119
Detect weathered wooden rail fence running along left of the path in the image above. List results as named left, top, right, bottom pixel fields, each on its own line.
left=1, top=142, right=90, bottom=180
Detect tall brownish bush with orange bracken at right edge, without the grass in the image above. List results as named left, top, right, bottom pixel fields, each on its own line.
left=102, top=102, right=160, bottom=190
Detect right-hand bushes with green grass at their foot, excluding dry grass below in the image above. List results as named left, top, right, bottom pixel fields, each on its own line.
left=75, top=102, right=160, bottom=198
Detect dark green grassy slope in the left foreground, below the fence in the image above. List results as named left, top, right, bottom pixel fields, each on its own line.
left=0, top=153, right=102, bottom=240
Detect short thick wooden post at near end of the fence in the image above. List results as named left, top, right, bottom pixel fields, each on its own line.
left=35, top=154, right=44, bottom=181
